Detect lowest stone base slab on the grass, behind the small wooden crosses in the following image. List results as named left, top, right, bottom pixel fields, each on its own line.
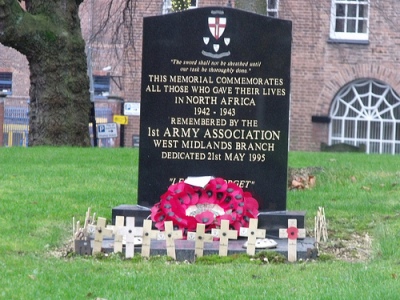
left=76, top=238, right=317, bottom=262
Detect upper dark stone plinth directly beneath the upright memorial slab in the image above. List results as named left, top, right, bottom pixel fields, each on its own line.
left=112, top=204, right=306, bottom=238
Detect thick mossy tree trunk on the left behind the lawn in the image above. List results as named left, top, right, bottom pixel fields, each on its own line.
left=0, top=0, right=90, bottom=146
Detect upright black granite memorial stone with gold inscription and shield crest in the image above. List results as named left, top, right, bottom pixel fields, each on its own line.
left=138, top=7, right=292, bottom=211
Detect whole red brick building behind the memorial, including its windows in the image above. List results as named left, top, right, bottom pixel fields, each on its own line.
left=0, top=0, right=400, bottom=154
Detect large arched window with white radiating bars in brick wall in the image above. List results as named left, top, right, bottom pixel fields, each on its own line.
left=329, top=79, right=400, bottom=154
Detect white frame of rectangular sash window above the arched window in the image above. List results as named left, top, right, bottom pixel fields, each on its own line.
left=330, top=0, right=370, bottom=41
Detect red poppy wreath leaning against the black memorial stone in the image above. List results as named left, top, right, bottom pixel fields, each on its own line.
left=151, top=178, right=258, bottom=236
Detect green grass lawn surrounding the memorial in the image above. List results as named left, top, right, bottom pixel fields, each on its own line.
left=0, top=147, right=400, bottom=299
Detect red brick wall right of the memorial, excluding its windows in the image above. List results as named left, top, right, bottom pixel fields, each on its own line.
left=280, top=0, right=400, bottom=150
